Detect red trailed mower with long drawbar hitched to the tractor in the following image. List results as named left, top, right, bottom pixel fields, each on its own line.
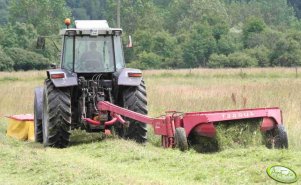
left=85, top=101, right=283, bottom=150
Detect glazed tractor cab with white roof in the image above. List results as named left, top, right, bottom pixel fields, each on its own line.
left=60, top=20, right=125, bottom=73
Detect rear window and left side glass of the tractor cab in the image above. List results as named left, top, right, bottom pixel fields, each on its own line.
left=62, top=36, right=115, bottom=73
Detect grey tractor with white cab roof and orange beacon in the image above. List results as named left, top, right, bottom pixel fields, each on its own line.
left=34, top=20, right=147, bottom=148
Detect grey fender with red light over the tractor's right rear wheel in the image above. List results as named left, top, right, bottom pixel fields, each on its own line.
left=117, top=68, right=142, bottom=86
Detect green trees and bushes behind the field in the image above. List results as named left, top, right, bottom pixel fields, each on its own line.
left=0, top=0, right=301, bottom=71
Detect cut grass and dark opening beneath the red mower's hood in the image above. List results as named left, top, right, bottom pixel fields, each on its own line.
left=188, top=119, right=265, bottom=153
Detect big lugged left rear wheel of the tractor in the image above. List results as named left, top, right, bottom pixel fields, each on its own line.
left=42, top=80, right=71, bottom=148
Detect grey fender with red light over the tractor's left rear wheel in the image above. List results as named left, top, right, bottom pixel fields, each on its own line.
left=47, top=69, right=78, bottom=87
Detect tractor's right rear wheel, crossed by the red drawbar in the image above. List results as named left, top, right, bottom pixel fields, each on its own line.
left=116, top=80, right=147, bottom=143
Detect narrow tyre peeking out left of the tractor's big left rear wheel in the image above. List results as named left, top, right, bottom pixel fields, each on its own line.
left=34, top=87, right=43, bottom=143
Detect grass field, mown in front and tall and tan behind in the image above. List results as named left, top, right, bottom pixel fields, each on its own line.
left=0, top=68, right=301, bottom=185
